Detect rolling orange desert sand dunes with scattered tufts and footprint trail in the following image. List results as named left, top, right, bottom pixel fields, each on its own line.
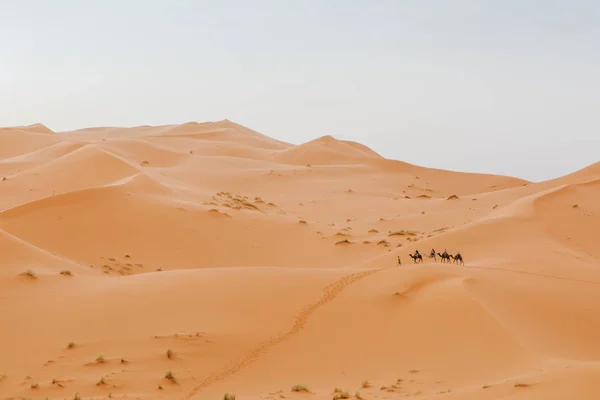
left=0, top=120, right=600, bottom=400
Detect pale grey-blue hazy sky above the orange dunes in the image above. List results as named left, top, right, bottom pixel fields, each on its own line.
left=0, top=0, right=600, bottom=181
